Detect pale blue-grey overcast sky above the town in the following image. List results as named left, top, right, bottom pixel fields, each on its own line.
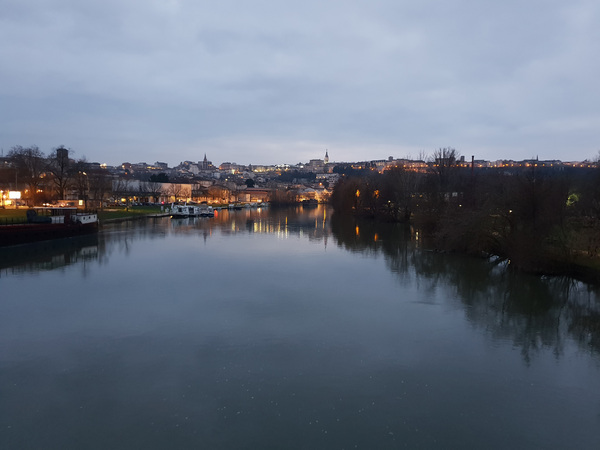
left=0, top=0, right=600, bottom=165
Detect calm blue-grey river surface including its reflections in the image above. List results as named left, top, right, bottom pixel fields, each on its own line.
left=0, top=207, right=600, bottom=449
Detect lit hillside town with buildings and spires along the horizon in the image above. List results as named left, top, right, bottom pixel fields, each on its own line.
left=0, top=146, right=598, bottom=208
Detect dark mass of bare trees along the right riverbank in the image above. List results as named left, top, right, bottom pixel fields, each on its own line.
left=331, top=148, right=600, bottom=277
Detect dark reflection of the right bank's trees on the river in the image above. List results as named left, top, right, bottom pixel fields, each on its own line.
left=331, top=215, right=600, bottom=361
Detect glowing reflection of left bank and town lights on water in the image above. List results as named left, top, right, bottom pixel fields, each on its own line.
left=0, top=206, right=330, bottom=276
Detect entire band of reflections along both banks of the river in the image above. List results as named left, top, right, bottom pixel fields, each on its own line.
left=0, top=206, right=600, bottom=362
